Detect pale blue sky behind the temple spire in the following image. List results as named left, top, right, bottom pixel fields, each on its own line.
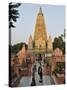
left=11, top=3, right=65, bottom=45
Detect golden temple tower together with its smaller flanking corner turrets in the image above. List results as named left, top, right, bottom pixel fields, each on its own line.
left=28, top=7, right=53, bottom=52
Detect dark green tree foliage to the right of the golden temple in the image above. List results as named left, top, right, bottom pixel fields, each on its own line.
left=53, top=36, right=65, bottom=54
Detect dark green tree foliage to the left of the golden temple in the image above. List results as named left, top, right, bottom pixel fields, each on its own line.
left=11, top=43, right=28, bottom=54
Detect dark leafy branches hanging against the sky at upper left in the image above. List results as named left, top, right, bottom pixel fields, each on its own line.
left=9, top=2, right=20, bottom=29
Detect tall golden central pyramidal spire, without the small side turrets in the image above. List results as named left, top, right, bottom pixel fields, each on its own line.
left=34, top=7, right=47, bottom=48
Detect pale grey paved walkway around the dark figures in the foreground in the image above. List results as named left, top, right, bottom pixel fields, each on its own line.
left=19, top=62, right=54, bottom=87
